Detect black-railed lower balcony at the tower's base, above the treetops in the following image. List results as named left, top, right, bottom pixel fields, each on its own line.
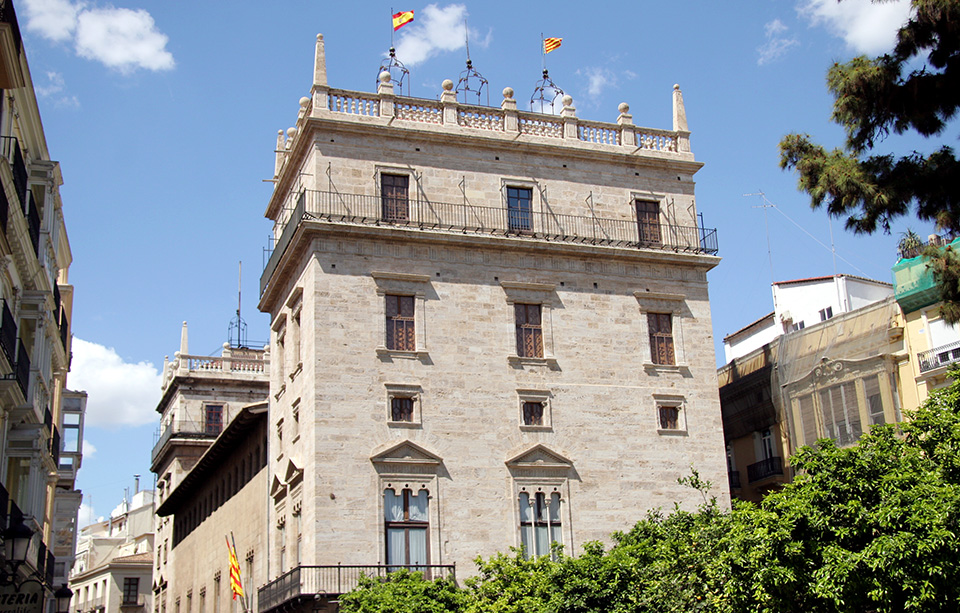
left=257, top=564, right=456, bottom=613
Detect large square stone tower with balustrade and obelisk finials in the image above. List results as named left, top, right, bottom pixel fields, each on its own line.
left=244, top=37, right=725, bottom=611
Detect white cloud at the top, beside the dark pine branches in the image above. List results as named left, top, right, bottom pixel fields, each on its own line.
left=797, top=0, right=910, bottom=55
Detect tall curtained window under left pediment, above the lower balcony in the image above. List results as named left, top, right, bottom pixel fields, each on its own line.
left=383, top=489, right=430, bottom=566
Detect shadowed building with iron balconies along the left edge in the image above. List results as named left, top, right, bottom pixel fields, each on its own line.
left=0, top=0, right=79, bottom=610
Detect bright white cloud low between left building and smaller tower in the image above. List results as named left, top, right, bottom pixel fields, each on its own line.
left=70, top=337, right=161, bottom=427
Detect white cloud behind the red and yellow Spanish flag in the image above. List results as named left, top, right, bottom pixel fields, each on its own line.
left=396, top=4, right=491, bottom=66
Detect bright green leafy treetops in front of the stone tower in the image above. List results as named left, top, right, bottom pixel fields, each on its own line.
left=342, top=370, right=960, bottom=613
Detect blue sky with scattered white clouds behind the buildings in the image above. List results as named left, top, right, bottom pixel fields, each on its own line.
left=17, top=0, right=931, bottom=520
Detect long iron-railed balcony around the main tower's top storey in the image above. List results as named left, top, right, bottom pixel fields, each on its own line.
left=260, top=190, right=718, bottom=295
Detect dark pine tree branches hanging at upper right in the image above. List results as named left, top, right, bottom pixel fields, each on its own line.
left=780, top=0, right=960, bottom=323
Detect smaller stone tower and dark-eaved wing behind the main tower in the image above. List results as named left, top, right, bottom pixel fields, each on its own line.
left=151, top=322, right=270, bottom=612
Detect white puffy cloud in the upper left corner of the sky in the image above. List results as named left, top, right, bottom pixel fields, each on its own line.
left=25, top=0, right=175, bottom=74
